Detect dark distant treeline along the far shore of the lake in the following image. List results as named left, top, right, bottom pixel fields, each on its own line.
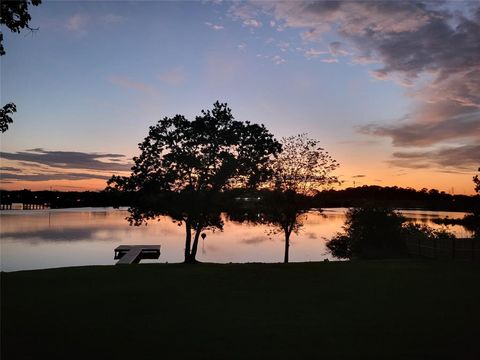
left=0, top=186, right=480, bottom=213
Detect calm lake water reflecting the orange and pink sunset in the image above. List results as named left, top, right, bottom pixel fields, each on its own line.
left=0, top=208, right=471, bottom=271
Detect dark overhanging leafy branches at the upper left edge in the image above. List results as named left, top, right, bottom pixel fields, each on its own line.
left=0, top=0, right=42, bottom=133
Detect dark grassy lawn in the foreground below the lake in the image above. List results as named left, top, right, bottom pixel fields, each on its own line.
left=1, top=260, right=480, bottom=360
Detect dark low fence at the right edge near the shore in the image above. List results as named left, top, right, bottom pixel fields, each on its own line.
left=407, top=238, right=480, bottom=262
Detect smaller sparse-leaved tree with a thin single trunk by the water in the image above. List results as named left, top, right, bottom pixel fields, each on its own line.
left=269, top=134, right=339, bottom=263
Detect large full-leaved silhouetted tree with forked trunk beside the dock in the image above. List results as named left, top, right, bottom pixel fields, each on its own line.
left=109, top=102, right=281, bottom=263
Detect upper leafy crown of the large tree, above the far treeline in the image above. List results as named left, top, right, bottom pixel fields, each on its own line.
left=111, top=102, right=281, bottom=192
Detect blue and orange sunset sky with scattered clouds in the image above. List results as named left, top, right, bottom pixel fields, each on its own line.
left=0, top=1, right=480, bottom=194
